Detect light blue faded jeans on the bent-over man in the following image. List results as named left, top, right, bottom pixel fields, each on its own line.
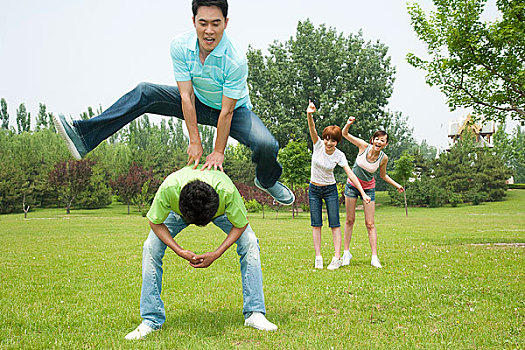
left=140, top=212, right=266, bottom=329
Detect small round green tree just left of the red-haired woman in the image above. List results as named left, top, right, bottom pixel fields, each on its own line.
left=278, top=140, right=312, bottom=217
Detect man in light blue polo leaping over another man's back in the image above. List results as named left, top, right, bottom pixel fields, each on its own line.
left=53, top=0, right=295, bottom=205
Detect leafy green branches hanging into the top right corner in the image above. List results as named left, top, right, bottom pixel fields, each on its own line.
left=407, top=0, right=525, bottom=121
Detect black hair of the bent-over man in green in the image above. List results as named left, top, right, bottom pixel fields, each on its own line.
left=179, top=180, right=219, bottom=226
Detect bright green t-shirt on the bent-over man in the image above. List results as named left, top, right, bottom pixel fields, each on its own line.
left=147, top=166, right=248, bottom=228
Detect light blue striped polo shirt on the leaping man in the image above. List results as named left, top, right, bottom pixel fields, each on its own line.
left=170, top=31, right=252, bottom=110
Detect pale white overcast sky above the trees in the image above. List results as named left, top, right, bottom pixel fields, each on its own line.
left=0, top=0, right=497, bottom=147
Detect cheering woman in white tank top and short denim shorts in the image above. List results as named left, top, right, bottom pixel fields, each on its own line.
left=343, top=117, right=404, bottom=268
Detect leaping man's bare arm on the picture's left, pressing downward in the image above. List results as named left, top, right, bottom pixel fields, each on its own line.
left=177, top=81, right=202, bottom=169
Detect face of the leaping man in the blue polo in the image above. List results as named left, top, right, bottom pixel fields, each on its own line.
left=193, top=6, right=228, bottom=56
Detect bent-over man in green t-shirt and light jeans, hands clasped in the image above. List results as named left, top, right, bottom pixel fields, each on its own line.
left=126, top=166, right=277, bottom=340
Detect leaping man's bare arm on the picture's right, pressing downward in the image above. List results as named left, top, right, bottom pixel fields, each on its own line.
left=201, top=96, right=237, bottom=171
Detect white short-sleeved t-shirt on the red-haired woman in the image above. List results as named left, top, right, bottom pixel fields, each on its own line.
left=310, top=138, right=348, bottom=185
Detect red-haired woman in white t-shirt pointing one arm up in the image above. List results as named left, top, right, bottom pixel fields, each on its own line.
left=306, top=101, right=370, bottom=270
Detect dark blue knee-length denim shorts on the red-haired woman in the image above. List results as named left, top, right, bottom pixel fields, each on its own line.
left=308, top=183, right=341, bottom=227
